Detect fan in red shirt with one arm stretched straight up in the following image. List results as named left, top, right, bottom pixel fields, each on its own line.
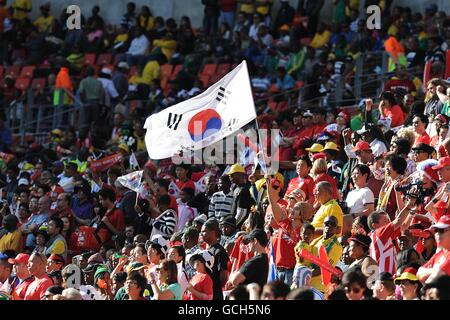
left=267, top=182, right=314, bottom=285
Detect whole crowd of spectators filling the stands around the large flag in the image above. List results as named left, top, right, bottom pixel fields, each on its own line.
left=0, top=0, right=450, bottom=300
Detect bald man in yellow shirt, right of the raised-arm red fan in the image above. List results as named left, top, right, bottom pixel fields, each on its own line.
left=311, top=181, right=343, bottom=236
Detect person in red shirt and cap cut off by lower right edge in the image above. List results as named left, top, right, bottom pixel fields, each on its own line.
left=417, top=215, right=450, bottom=283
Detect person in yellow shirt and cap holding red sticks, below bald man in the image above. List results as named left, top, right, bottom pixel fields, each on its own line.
left=311, top=216, right=344, bottom=292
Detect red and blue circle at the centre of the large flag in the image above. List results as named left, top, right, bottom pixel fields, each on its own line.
left=188, top=109, right=222, bottom=142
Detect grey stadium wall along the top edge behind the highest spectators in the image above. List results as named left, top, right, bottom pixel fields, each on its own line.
left=27, top=0, right=450, bottom=27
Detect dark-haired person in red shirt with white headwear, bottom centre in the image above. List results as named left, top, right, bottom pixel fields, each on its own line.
left=187, top=250, right=214, bottom=300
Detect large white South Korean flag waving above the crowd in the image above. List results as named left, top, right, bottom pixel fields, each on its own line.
left=144, top=61, right=256, bottom=159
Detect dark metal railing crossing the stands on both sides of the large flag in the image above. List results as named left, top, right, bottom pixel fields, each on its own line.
left=6, top=51, right=420, bottom=143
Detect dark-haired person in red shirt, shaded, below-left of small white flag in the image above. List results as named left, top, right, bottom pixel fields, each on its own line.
left=98, top=188, right=125, bottom=243
